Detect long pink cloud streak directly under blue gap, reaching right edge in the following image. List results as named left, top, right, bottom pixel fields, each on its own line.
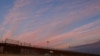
left=35, top=20, right=100, bottom=45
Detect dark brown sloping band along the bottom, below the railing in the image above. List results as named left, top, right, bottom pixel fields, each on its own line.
left=0, top=40, right=99, bottom=56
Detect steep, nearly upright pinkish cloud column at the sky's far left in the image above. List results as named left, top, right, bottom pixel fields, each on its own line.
left=2, top=0, right=32, bottom=38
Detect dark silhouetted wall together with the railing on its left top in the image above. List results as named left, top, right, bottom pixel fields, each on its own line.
left=0, top=39, right=98, bottom=56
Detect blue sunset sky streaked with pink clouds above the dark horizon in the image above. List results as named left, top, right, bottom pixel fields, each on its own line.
left=0, top=0, right=100, bottom=49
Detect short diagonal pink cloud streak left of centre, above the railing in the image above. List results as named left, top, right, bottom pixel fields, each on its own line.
left=17, top=21, right=61, bottom=41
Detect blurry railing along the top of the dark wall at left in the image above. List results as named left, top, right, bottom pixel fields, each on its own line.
left=0, top=39, right=50, bottom=49
